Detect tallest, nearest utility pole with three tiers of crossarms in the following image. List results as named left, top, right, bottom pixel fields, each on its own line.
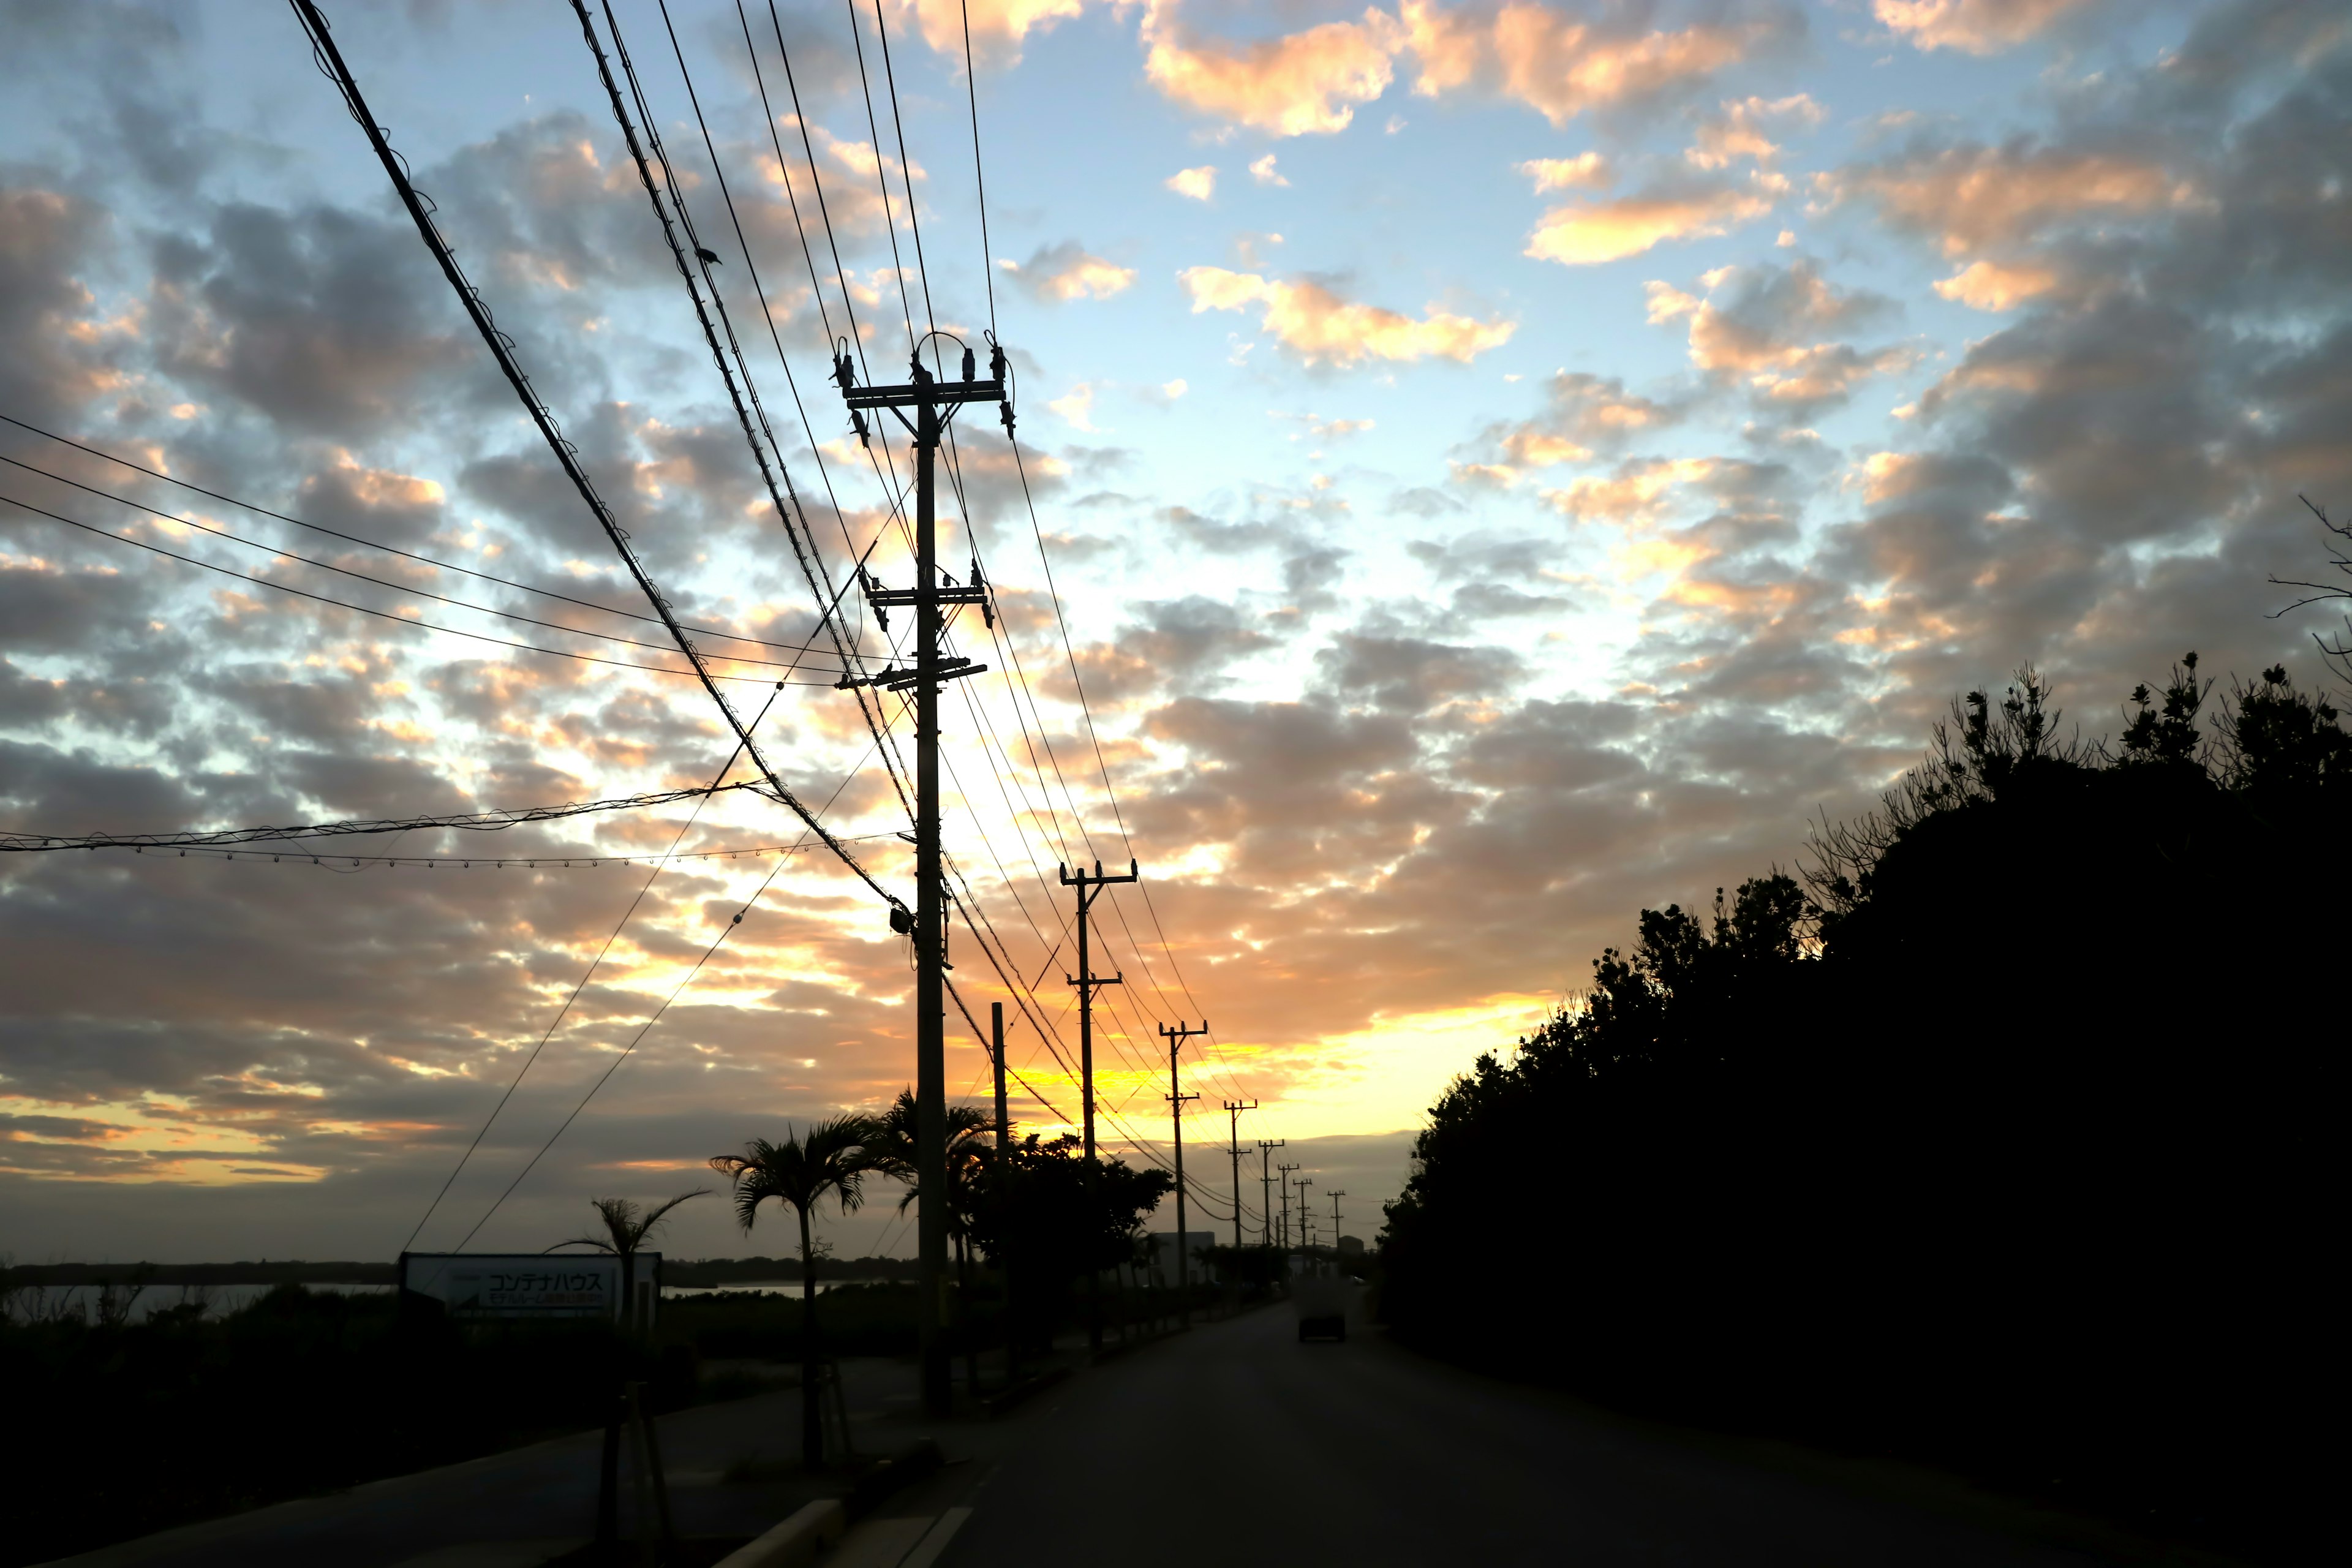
left=832, top=345, right=1011, bottom=1415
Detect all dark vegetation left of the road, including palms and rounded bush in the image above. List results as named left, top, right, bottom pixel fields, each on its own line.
left=0, top=1112, right=1174, bottom=1568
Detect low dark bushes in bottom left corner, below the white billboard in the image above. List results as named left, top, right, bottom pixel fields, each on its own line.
left=0, top=1286, right=694, bottom=1563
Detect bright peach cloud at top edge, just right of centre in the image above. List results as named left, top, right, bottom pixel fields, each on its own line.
left=1143, top=5, right=1402, bottom=137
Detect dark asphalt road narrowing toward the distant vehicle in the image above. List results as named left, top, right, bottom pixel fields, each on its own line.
left=917, top=1307, right=2091, bottom=1568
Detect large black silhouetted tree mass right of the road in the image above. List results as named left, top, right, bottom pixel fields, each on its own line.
left=1383, top=654, right=2352, bottom=1556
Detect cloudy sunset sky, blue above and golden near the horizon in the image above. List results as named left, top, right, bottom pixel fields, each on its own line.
left=0, top=0, right=2352, bottom=1260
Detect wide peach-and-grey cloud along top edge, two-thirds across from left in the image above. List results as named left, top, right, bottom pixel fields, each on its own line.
left=1400, top=0, right=1804, bottom=127
